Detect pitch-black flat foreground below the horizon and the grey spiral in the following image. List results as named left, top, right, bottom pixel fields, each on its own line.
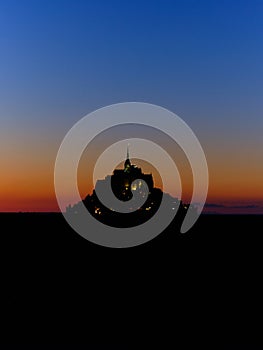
left=0, top=214, right=263, bottom=349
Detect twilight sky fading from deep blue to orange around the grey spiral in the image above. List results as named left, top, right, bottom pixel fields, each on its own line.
left=0, top=0, right=263, bottom=213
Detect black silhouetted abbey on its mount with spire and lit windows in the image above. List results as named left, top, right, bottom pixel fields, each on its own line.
left=67, top=149, right=195, bottom=227
